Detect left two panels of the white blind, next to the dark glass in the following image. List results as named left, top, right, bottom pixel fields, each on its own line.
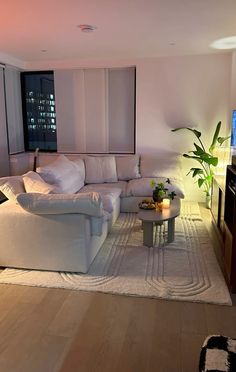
left=54, top=69, right=107, bottom=153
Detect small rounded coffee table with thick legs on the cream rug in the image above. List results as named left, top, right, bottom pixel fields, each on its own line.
left=138, top=198, right=180, bottom=247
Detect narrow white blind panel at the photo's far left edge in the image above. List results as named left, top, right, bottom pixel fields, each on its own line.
left=0, top=67, right=10, bottom=177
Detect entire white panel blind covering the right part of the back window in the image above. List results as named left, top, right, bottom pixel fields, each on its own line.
left=54, top=68, right=135, bottom=153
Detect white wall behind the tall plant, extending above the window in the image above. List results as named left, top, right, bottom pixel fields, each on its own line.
left=11, top=53, right=232, bottom=200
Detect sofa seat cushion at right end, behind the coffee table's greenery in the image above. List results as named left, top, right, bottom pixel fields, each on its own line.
left=127, top=177, right=184, bottom=198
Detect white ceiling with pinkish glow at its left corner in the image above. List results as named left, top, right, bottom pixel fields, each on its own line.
left=0, top=0, right=236, bottom=67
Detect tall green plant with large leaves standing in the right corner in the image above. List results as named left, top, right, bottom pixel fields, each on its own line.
left=171, top=121, right=230, bottom=208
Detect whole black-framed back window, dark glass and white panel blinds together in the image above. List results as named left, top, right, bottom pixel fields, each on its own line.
left=21, top=67, right=136, bottom=154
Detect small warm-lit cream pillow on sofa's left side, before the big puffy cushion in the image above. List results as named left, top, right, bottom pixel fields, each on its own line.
left=23, top=171, right=55, bottom=194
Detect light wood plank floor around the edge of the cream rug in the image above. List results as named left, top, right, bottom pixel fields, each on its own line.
left=0, top=208, right=236, bottom=372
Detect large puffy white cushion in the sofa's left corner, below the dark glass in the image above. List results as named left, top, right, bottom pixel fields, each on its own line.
left=37, top=155, right=85, bottom=194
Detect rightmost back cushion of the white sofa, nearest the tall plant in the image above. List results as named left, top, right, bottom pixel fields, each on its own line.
left=140, top=154, right=182, bottom=179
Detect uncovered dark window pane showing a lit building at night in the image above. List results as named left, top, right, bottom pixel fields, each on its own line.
left=21, top=71, right=57, bottom=151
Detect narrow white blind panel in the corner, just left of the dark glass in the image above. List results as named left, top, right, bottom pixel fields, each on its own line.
left=5, top=67, right=24, bottom=154
